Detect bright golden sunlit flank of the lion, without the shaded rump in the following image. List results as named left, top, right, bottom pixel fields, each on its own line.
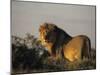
left=63, top=37, right=83, bottom=62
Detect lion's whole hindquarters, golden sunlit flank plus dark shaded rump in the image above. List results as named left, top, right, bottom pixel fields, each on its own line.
left=63, top=36, right=91, bottom=62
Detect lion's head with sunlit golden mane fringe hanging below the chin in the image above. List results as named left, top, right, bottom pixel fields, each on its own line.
left=39, top=23, right=57, bottom=53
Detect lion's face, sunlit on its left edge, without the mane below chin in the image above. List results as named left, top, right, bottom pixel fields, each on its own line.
left=39, top=23, right=55, bottom=43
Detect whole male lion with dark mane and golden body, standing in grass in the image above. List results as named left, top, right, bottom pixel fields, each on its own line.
left=39, top=23, right=91, bottom=62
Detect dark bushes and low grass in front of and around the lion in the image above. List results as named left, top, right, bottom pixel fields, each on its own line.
left=12, top=34, right=96, bottom=74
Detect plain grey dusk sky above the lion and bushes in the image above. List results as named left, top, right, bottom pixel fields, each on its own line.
left=11, top=1, right=96, bottom=48
